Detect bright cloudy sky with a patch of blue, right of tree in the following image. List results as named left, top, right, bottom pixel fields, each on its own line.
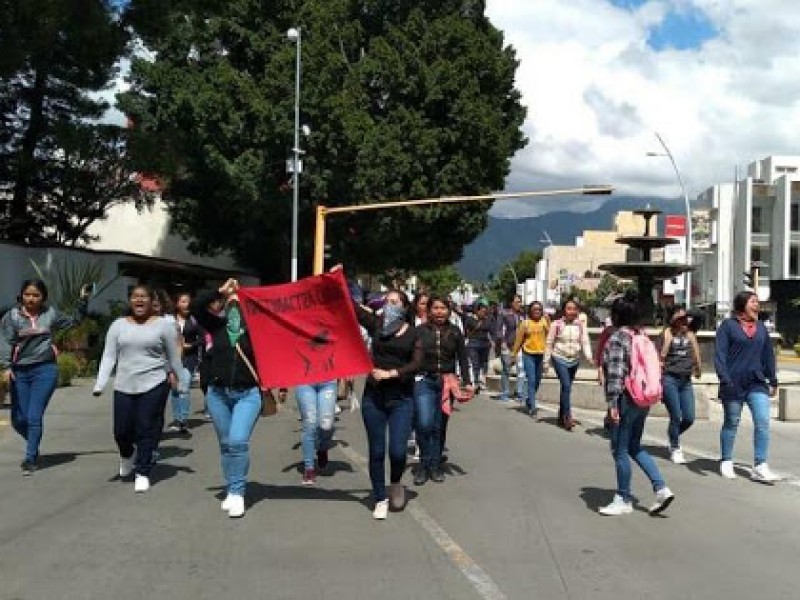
left=487, top=0, right=800, bottom=217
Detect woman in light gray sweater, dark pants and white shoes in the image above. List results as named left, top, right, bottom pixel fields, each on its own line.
left=94, top=285, right=182, bottom=492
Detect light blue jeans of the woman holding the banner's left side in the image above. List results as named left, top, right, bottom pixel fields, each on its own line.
left=206, top=385, right=261, bottom=496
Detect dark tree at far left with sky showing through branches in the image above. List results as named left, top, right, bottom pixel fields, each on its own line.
left=0, top=0, right=149, bottom=245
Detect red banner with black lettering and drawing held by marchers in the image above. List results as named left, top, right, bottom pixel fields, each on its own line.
left=239, top=271, right=372, bottom=388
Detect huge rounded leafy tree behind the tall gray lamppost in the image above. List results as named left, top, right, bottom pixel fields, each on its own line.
left=121, top=0, right=525, bottom=279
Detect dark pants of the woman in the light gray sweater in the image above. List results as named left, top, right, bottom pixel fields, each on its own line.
left=114, top=381, right=169, bottom=476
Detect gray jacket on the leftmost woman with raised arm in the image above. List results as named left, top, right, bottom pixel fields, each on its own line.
left=0, top=300, right=88, bottom=370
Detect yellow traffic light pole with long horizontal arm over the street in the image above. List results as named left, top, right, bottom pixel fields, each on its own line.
left=313, top=185, right=614, bottom=275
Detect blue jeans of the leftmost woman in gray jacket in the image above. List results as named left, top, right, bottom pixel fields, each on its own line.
left=11, top=362, right=58, bottom=462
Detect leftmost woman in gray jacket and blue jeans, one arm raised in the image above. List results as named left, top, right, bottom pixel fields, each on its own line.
left=0, top=279, right=90, bottom=475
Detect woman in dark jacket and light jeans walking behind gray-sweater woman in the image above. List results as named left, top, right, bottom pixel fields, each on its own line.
left=169, top=293, right=204, bottom=436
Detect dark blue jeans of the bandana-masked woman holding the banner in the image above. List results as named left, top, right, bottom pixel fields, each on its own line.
left=361, top=383, right=414, bottom=502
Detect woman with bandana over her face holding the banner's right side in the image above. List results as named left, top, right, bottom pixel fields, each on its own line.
left=356, top=290, right=422, bottom=519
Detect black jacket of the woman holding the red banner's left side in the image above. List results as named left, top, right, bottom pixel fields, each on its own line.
left=190, top=292, right=258, bottom=390
